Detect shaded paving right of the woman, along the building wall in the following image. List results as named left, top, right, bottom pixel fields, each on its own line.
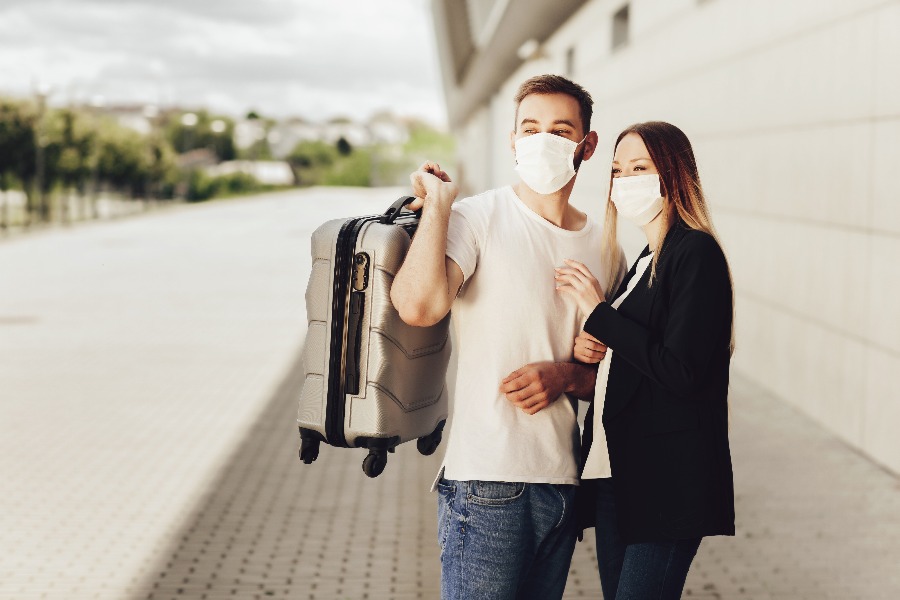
left=685, top=376, right=900, bottom=600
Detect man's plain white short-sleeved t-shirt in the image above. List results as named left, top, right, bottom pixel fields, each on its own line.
left=442, top=187, right=620, bottom=484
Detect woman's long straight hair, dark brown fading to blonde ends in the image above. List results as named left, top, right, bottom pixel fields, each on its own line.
left=603, top=121, right=734, bottom=353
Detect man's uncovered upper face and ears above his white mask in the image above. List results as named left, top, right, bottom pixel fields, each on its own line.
left=509, top=94, right=596, bottom=169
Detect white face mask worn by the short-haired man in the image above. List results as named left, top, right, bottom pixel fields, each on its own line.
left=516, top=133, right=587, bottom=194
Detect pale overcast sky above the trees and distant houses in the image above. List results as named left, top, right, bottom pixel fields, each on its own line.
left=0, top=0, right=446, bottom=125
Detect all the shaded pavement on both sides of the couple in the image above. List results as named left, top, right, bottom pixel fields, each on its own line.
left=128, top=364, right=900, bottom=600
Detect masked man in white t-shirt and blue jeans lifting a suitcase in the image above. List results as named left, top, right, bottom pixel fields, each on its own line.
left=391, top=75, right=624, bottom=600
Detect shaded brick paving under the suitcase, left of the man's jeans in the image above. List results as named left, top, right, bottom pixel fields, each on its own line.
left=135, top=344, right=439, bottom=600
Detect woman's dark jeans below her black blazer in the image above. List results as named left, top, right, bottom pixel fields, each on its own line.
left=595, top=478, right=701, bottom=600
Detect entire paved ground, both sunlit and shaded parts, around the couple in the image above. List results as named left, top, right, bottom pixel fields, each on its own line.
left=0, top=190, right=900, bottom=600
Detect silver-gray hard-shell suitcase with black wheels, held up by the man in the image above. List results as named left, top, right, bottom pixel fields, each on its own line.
left=297, top=197, right=450, bottom=477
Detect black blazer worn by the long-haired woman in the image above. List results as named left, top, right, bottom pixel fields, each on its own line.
left=579, top=223, right=734, bottom=543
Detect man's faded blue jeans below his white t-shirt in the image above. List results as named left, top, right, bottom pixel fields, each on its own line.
left=438, top=478, right=576, bottom=600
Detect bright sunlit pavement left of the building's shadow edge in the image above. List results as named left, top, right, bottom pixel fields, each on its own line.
left=0, top=189, right=399, bottom=599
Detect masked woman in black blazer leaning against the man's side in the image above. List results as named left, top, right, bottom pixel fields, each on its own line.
left=556, top=122, right=734, bottom=600
